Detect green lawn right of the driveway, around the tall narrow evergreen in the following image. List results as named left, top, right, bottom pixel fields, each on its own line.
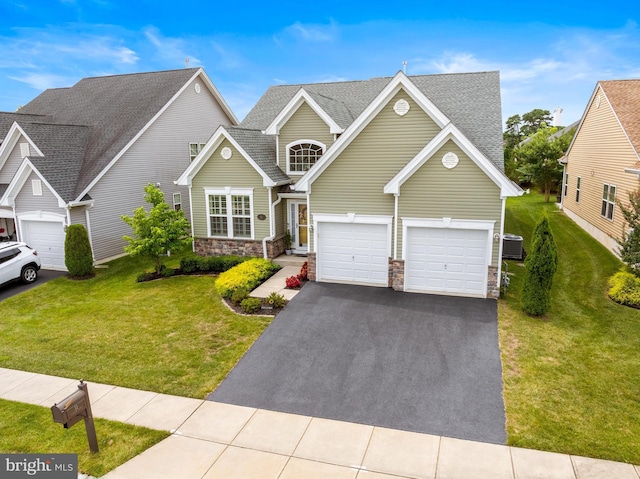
left=499, top=194, right=640, bottom=464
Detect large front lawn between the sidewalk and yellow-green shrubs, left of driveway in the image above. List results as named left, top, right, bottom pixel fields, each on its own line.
left=0, top=253, right=270, bottom=399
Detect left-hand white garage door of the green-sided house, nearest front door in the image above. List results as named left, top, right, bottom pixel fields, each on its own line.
left=317, top=222, right=389, bottom=286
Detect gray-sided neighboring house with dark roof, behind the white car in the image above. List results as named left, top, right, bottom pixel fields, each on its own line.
left=0, top=68, right=238, bottom=270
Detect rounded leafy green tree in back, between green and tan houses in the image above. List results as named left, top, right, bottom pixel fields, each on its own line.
left=514, top=128, right=573, bottom=202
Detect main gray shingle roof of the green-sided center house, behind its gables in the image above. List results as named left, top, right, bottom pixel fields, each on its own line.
left=240, top=71, right=504, bottom=170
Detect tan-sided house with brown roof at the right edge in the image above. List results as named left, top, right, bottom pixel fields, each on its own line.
left=562, top=80, right=640, bottom=253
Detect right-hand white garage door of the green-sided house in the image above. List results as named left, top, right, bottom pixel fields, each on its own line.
left=405, top=227, right=488, bottom=297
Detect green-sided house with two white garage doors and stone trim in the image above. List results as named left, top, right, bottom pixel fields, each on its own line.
left=176, top=72, right=522, bottom=297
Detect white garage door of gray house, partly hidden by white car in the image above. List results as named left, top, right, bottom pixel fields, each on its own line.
left=21, top=221, right=67, bottom=270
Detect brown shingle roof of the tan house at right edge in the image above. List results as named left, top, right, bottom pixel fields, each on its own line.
left=600, top=80, right=640, bottom=154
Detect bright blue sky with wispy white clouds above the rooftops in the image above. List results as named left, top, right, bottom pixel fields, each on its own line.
left=0, top=0, right=640, bottom=124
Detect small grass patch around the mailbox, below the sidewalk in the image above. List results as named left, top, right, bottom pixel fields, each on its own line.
left=0, top=399, right=169, bottom=477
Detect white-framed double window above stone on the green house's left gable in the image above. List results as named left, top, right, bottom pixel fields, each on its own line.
left=205, top=188, right=254, bottom=239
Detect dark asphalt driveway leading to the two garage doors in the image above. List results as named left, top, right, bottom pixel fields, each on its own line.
left=208, top=282, right=506, bottom=444
